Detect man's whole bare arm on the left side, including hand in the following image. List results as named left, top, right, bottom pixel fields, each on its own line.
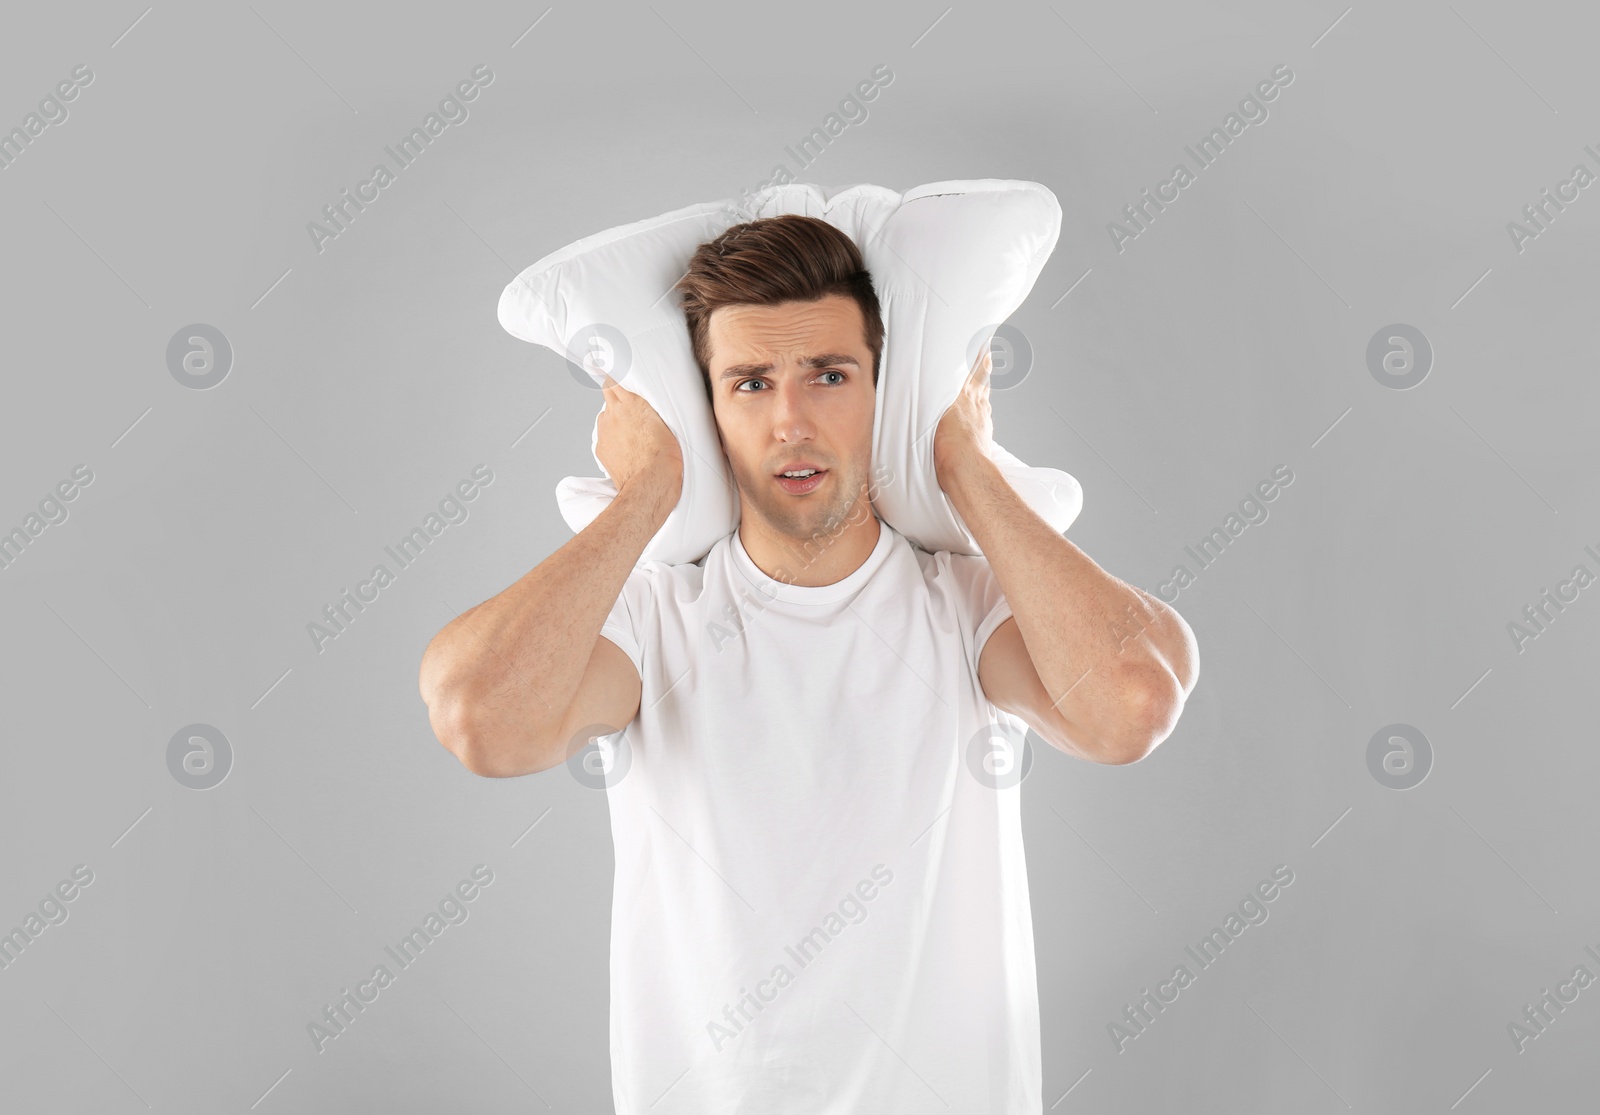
left=418, top=374, right=683, bottom=777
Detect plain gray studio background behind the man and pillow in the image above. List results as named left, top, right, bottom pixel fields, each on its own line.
left=0, top=0, right=1600, bottom=1112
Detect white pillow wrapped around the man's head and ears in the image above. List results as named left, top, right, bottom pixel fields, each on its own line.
left=499, top=179, right=1083, bottom=565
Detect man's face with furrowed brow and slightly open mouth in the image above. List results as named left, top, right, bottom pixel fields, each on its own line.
left=707, top=294, right=875, bottom=541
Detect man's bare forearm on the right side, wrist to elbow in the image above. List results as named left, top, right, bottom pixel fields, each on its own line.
left=941, top=453, right=1198, bottom=741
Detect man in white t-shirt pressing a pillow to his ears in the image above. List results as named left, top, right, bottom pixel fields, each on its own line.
left=421, top=216, right=1198, bottom=1115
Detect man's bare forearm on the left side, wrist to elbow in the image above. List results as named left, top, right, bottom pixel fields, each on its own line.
left=419, top=480, right=677, bottom=753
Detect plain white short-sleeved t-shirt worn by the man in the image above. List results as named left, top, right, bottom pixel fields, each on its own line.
left=602, top=522, right=1043, bottom=1115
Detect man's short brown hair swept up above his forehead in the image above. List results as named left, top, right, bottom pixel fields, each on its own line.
left=675, top=213, right=883, bottom=400
